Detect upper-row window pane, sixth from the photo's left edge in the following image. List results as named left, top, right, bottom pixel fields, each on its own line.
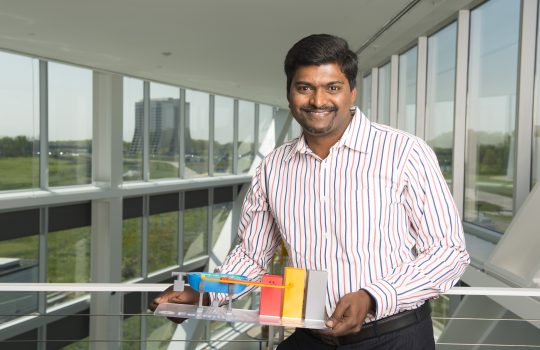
left=214, top=96, right=234, bottom=175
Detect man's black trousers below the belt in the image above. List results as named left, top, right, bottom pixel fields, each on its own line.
left=277, top=317, right=435, bottom=350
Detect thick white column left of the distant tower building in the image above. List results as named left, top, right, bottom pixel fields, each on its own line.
left=90, top=72, right=123, bottom=350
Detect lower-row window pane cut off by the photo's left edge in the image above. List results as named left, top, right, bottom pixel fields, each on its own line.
left=0, top=235, right=39, bottom=324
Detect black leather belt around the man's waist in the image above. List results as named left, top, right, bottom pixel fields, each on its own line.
left=301, top=301, right=431, bottom=346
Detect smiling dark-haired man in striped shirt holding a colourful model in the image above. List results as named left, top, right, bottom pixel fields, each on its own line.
left=152, top=34, right=469, bottom=350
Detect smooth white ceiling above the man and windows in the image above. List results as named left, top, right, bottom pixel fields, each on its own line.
left=0, top=0, right=469, bottom=106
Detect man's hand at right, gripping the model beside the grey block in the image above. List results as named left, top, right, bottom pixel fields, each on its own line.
left=322, top=289, right=375, bottom=336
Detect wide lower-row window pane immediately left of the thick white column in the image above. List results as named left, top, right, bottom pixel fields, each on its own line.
left=47, top=226, right=91, bottom=307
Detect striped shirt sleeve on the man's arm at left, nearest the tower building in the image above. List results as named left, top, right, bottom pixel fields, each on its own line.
left=210, top=161, right=281, bottom=304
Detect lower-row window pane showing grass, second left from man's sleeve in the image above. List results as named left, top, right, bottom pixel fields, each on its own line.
left=183, top=207, right=208, bottom=261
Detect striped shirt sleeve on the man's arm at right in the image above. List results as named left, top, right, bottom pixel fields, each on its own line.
left=364, top=139, right=470, bottom=319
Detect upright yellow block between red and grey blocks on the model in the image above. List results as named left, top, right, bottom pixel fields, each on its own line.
left=281, top=267, right=306, bottom=318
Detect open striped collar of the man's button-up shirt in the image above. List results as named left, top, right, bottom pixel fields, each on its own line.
left=283, top=107, right=371, bottom=161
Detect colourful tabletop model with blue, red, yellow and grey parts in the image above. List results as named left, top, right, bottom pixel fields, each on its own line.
left=154, top=267, right=328, bottom=329
